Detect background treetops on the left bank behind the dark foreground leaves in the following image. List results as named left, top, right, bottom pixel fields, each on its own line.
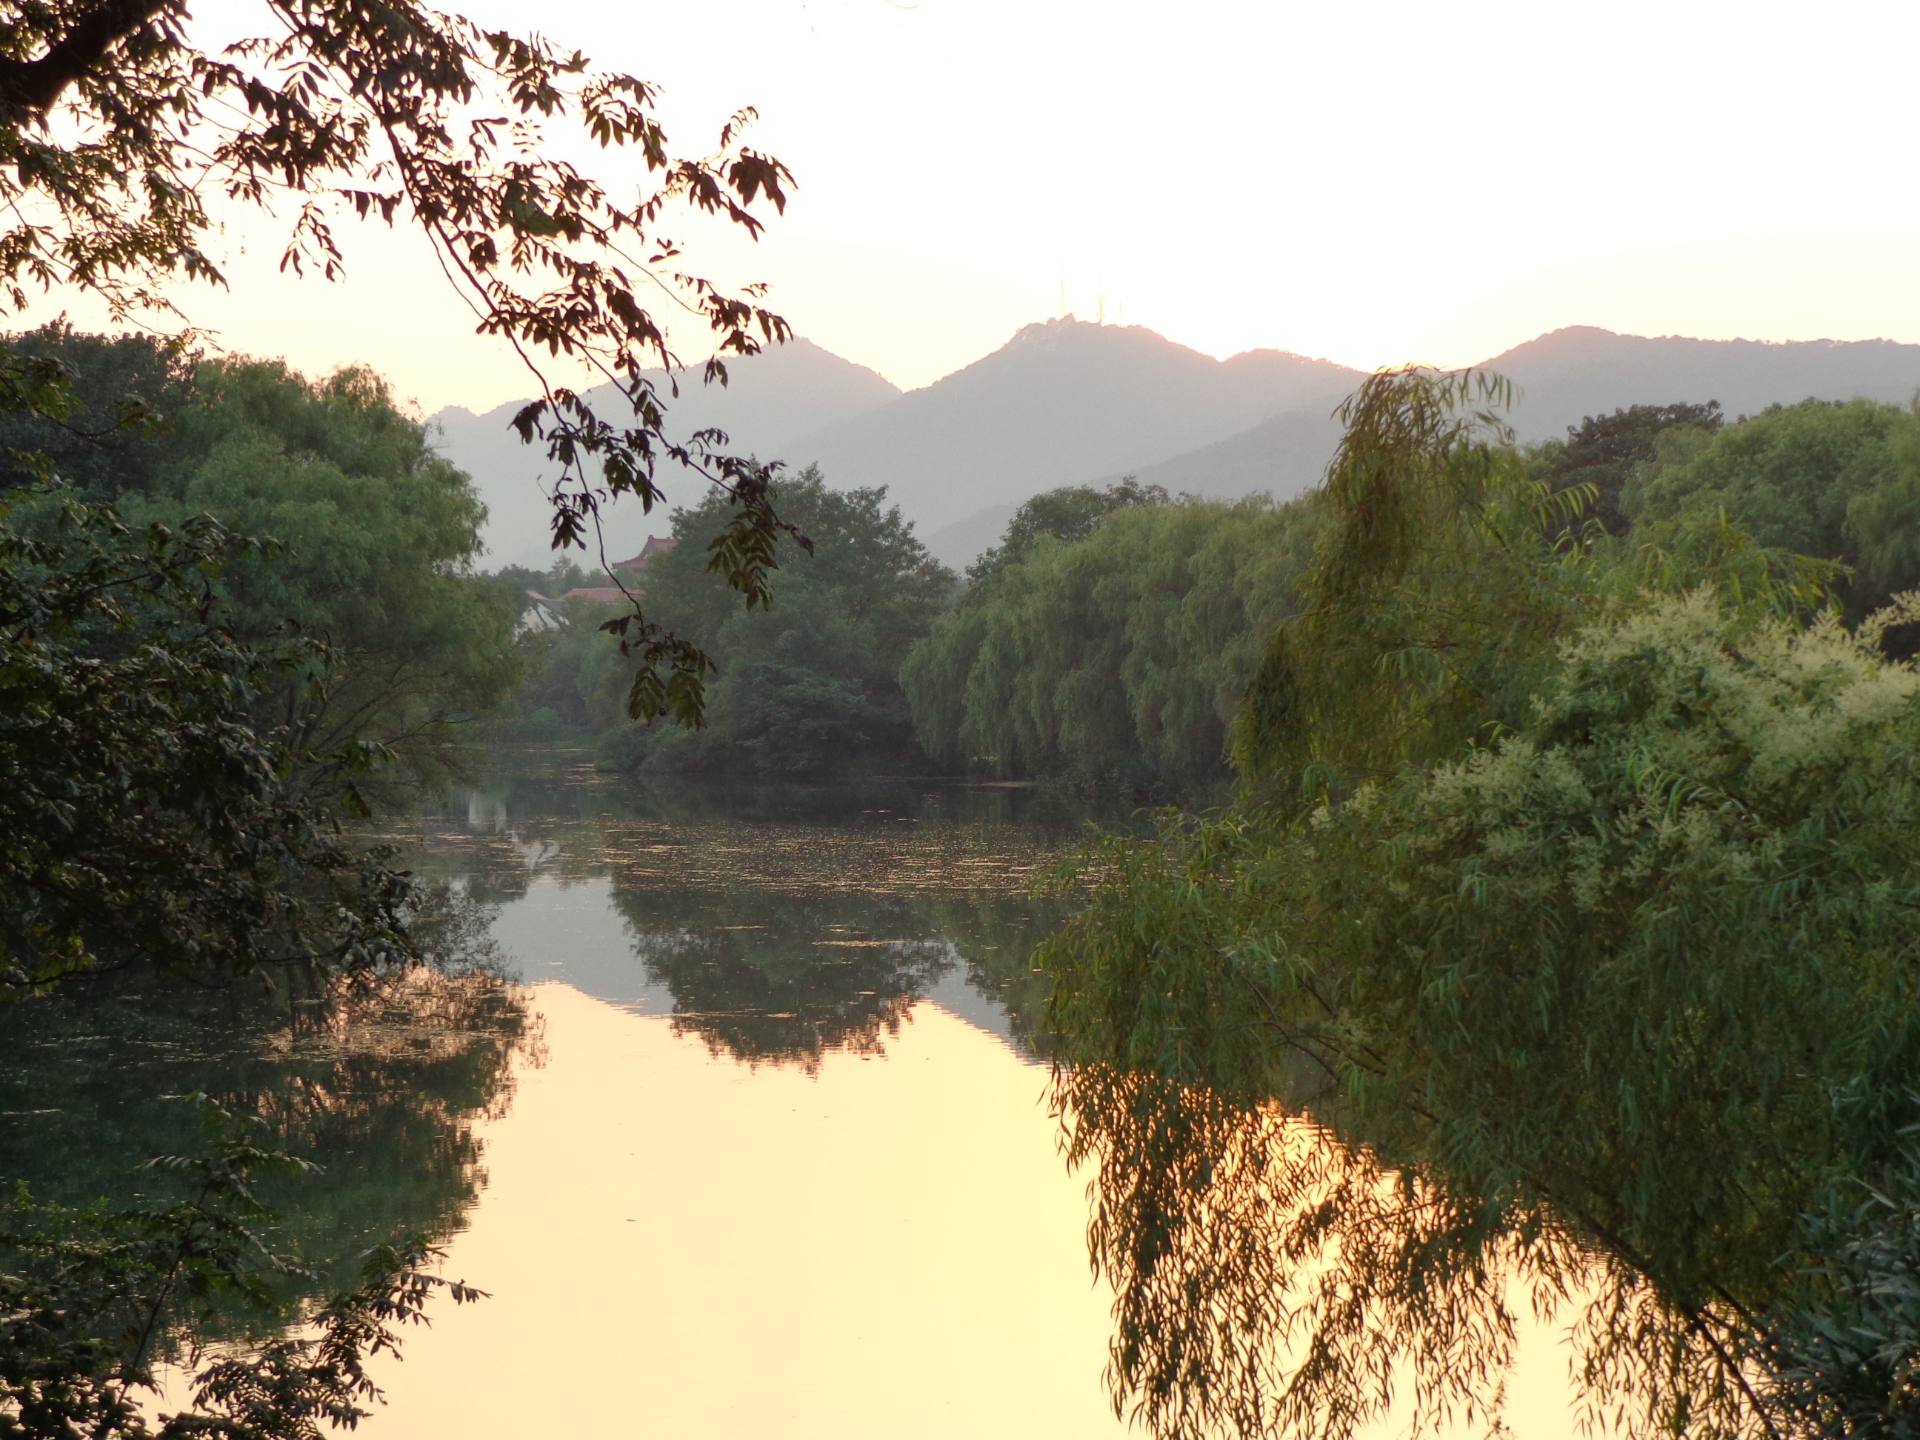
left=10, top=328, right=516, bottom=791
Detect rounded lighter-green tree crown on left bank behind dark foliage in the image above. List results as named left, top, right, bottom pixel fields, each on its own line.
left=127, top=361, right=516, bottom=791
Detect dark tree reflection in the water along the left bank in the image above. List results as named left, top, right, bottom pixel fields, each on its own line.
left=0, top=952, right=540, bottom=1329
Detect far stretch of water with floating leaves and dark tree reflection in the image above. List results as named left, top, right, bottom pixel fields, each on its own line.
left=389, top=755, right=1075, bottom=1071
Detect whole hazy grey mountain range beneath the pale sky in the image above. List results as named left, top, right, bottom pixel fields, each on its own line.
left=434, top=317, right=1920, bottom=566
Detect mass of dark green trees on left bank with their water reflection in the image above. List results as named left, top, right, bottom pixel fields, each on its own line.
left=0, top=341, right=526, bottom=1436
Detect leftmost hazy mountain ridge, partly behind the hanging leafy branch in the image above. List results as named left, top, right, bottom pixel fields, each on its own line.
left=428, top=340, right=900, bottom=568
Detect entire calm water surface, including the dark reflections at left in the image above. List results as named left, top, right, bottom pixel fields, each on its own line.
left=0, top=755, right=1571, bottom=1440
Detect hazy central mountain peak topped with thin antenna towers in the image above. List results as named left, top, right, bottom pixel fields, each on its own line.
left=783, top=317, right=1359, bottom=541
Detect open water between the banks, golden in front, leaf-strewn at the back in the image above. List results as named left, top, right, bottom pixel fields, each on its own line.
left=341, top=772, right=1572, bottom=1440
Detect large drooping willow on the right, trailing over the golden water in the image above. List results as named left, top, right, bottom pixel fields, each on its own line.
left=1039, top=371, right=1920, bottom=1438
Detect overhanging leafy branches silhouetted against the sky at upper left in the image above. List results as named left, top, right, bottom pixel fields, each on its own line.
left=0, top=0, right=799, bottom=720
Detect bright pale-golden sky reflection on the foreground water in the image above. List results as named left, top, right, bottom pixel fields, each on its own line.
left=369, top=985, right=1121, bottom=1440
